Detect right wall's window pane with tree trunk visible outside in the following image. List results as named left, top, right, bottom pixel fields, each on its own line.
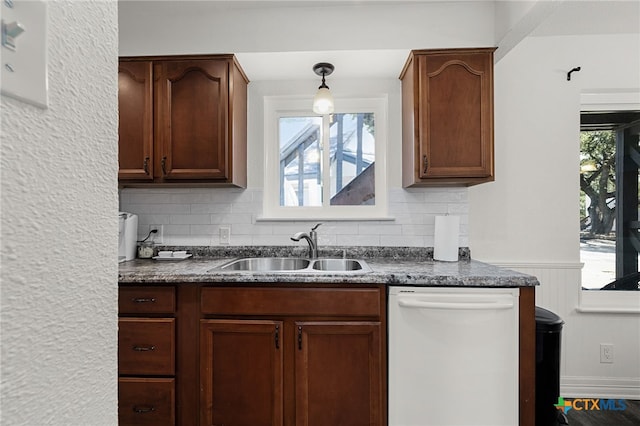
left=580, top=111, right=640, bottom=291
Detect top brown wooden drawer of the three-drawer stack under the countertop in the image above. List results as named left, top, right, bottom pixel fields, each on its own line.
left=118, top=286, right=176, bottom=314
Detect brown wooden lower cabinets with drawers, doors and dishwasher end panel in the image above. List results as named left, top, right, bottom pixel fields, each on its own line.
left=118, top=283, right=535, bottom=426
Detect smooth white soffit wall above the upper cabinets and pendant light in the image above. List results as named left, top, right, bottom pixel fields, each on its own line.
left=120, top=0, right=494, bottom=55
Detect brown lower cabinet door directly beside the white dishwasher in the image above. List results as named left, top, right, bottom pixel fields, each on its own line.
left=295, top=322, right=386, bottom=426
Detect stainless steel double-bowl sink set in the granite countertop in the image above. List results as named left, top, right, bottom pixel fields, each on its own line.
left=215, top=257, right=371, bottom=274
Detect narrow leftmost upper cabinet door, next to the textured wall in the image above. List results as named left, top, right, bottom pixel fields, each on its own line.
left=118, top=61, right=153, bottom=181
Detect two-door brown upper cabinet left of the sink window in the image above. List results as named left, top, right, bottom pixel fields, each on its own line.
left=119, top=55, right=248, bottom=187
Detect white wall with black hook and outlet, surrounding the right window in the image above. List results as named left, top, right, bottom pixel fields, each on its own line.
left=469, top=34, right=640, bottom=399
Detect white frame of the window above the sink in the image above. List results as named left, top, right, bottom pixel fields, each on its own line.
left=260, top=96, right=388, bottom=221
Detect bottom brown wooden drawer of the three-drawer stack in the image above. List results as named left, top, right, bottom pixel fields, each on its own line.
left=118, top=377, right=175, bottom=426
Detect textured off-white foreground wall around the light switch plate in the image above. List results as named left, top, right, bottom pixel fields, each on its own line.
left=0, top=0, right=118, bottom=426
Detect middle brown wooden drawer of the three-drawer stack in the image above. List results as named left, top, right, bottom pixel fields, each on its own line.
left=118, top=318, right=175, bottom=375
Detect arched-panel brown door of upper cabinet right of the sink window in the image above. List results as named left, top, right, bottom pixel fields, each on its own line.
left=417, top=50, right=493, bottom=179
